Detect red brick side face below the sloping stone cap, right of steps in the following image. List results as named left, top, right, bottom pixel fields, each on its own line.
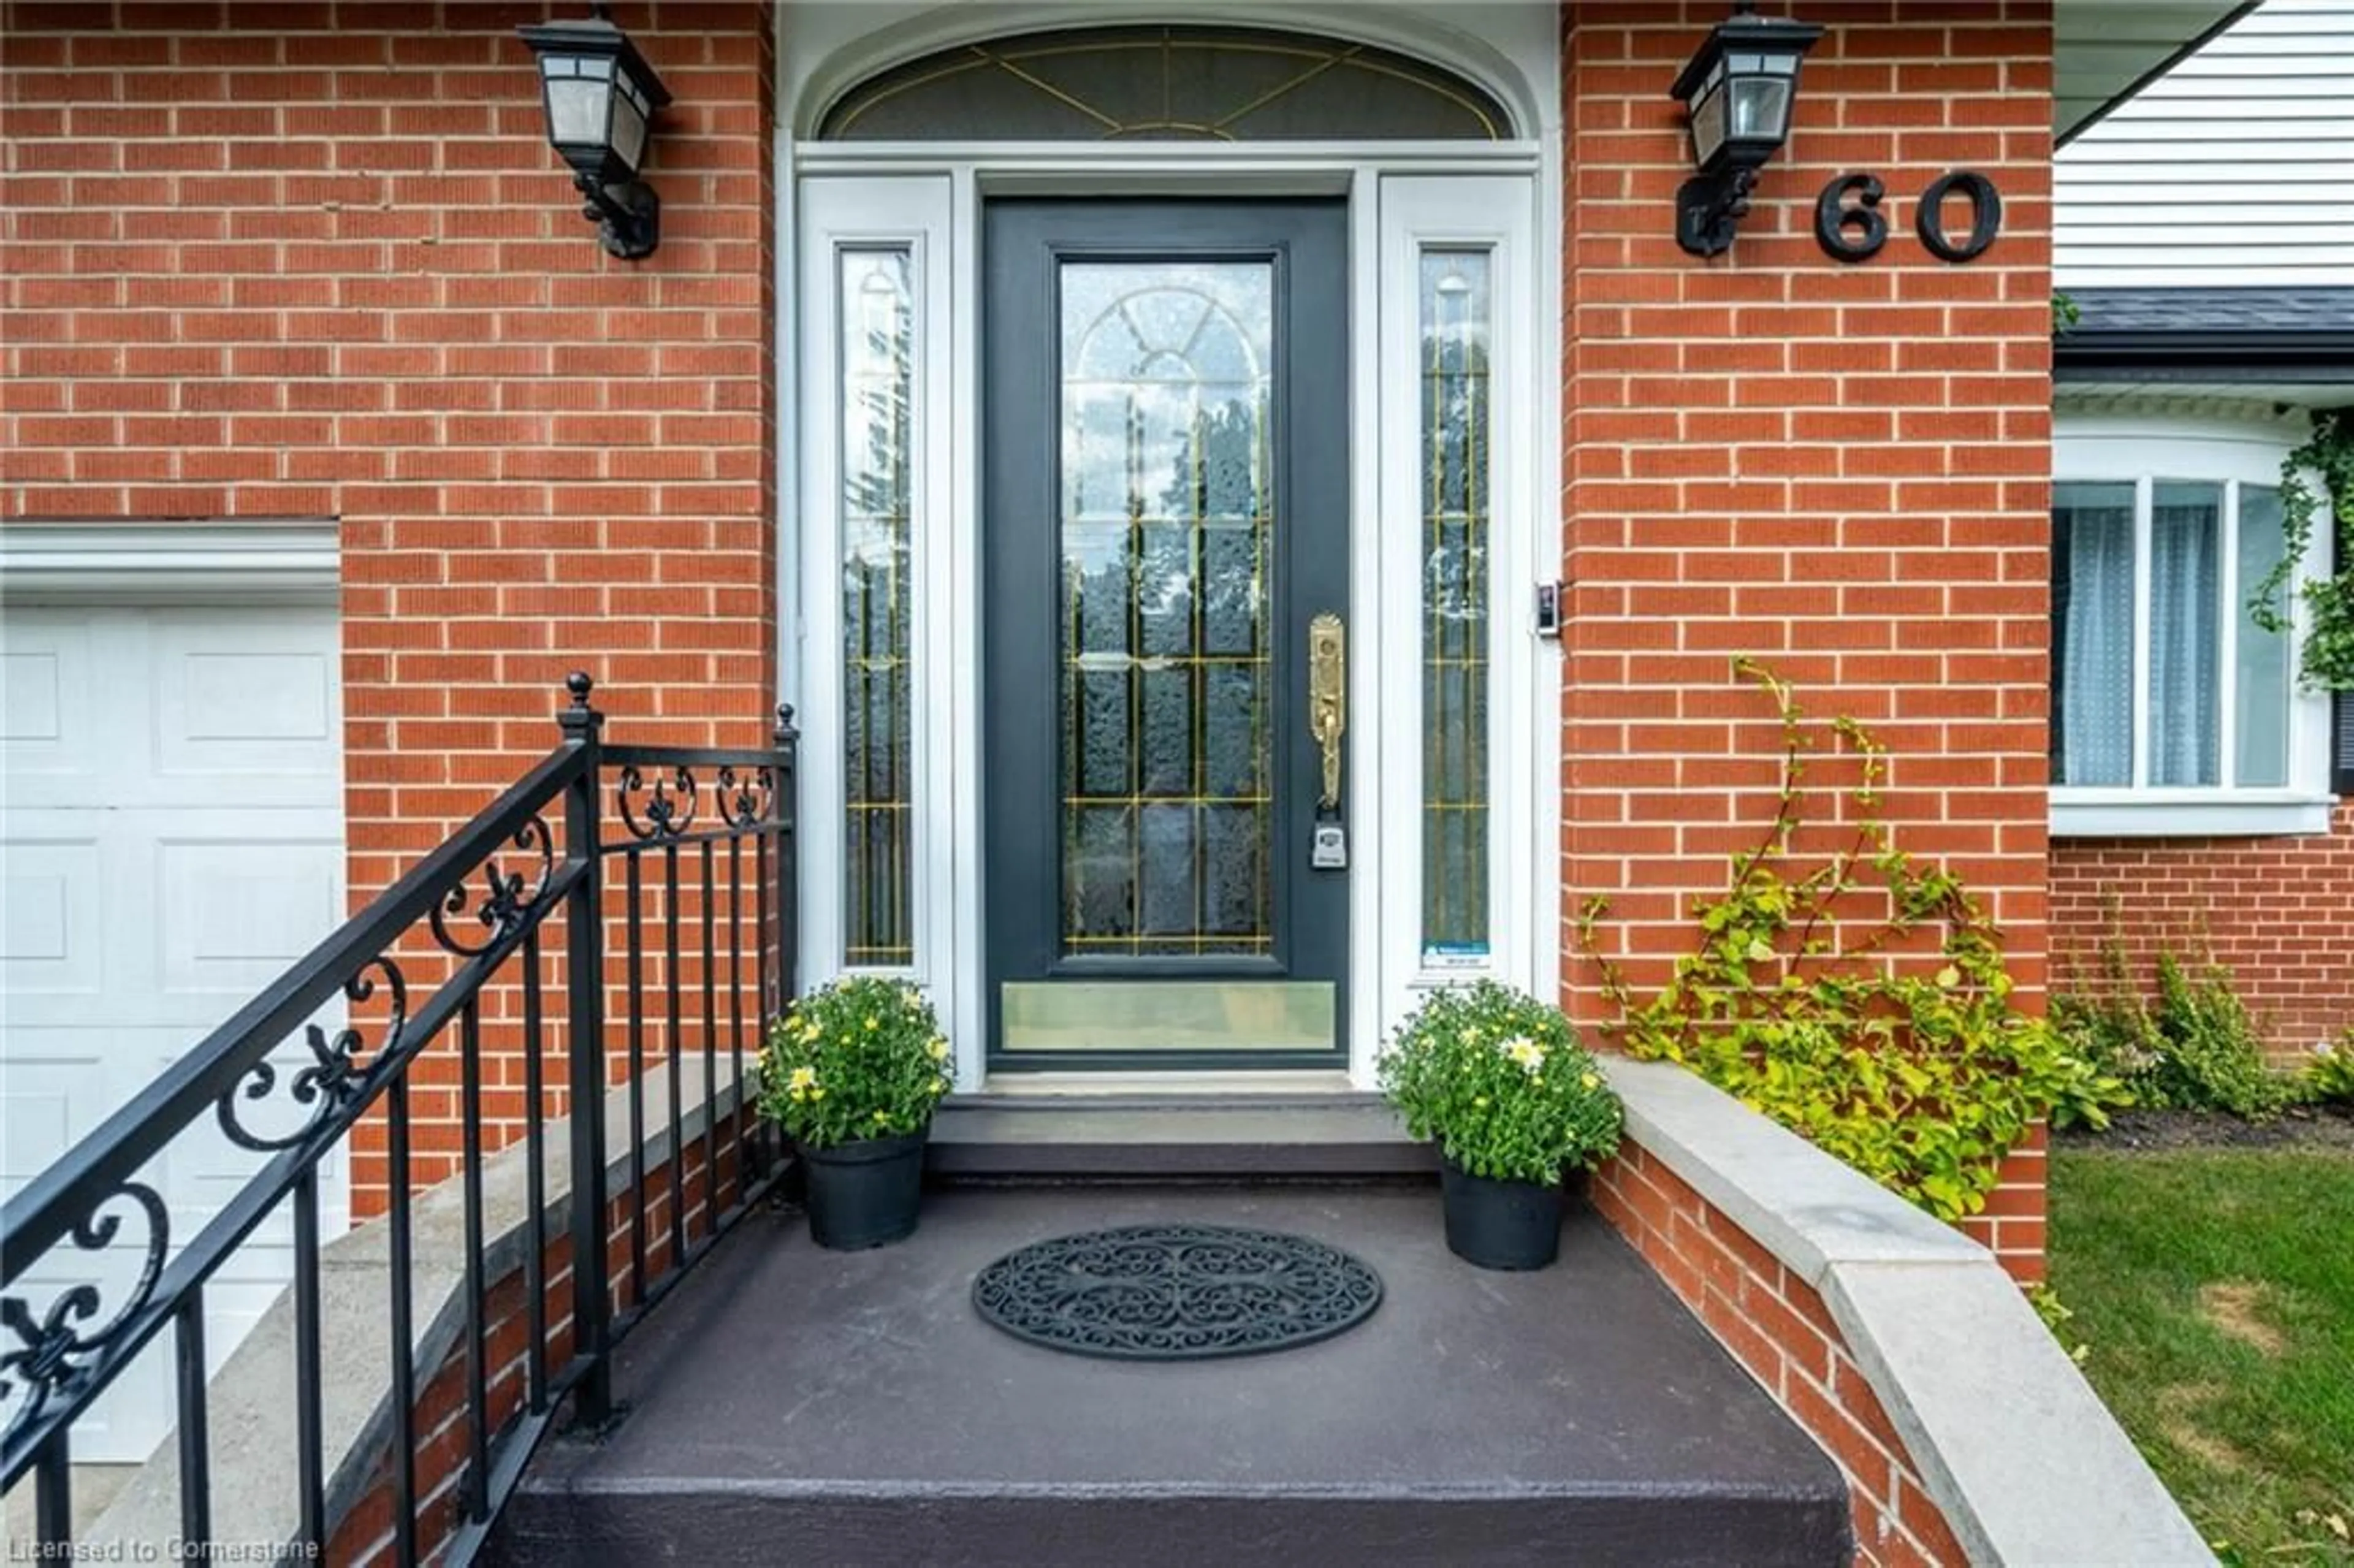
left=1594, top=1142, right=1968, bottom=1568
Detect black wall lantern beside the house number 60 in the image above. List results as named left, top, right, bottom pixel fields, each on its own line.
left=1671, top=0, right=1822, bottom=257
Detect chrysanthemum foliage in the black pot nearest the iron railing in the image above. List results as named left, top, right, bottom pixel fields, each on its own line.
left=760, top=975, right=951, bottom=1149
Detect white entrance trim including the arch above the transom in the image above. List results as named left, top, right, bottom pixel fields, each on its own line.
left=777, top=12, right=1563, bottom=1092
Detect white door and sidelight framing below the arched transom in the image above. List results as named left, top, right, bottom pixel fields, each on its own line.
left=779, top=143, right=1558, bottom=1090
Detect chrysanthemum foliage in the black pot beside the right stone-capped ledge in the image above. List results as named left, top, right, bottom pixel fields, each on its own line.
left=1382, top=980, right=1625, bottom=1187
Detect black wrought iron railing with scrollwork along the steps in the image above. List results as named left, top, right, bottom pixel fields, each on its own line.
left=0, top=676, right=796, bottom=1563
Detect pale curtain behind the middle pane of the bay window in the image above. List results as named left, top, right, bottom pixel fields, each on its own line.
left=2149, top=485, right=2222, bottom=786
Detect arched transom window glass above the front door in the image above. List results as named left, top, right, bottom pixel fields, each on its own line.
left=817, top=26, right=1514, bottom=141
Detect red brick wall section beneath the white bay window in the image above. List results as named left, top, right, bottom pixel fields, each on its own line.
left=2052, top=805, right=2354, bottom=1059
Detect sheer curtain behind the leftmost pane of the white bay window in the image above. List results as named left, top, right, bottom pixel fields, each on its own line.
left=2052, top=497, right=2133, bottom=784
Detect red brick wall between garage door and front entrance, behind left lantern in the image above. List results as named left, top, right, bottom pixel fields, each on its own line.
left=0, top=0, right=777, bottom=1215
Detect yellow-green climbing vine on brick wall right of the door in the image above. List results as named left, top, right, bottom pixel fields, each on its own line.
left=1580, top=659, right=2114, bottom=1220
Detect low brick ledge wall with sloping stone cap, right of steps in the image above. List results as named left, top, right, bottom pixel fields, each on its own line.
left=1594, top=1059, right=2213, bottom=1563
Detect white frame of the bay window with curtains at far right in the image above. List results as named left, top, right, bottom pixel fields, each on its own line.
left=2051, top=409, right=2337, bottom=838
